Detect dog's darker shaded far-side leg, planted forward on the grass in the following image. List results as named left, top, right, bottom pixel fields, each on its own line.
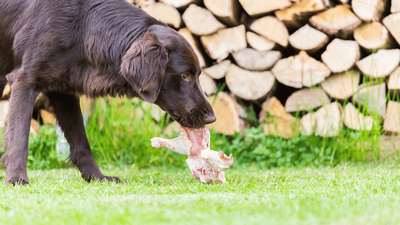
left=46, top=93, right=121, bottom=182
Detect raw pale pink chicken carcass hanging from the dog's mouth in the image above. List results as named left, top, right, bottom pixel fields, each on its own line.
left=151, top=126, right=233, bottom=184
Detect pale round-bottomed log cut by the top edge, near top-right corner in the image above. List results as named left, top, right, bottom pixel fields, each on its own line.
left=351, top=0, right=388, bottom=22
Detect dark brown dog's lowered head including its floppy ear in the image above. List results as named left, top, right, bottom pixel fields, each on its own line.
left=121, top=25, right=216, bottom=128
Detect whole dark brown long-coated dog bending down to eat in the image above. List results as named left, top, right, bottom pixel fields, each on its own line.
left=0, top=0, right=215, bottom=184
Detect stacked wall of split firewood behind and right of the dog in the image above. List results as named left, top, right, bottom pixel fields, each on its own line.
left=131, top=0, right=400, bottom=138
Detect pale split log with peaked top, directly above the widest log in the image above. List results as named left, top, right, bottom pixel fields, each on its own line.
left=289, top=24, right=329, bottom=53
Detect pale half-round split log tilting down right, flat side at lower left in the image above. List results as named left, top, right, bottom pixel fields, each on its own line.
left=250, top=16, right=289, bottom=47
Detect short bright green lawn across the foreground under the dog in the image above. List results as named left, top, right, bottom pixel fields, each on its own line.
left=0, top=165, right=400, bottom=224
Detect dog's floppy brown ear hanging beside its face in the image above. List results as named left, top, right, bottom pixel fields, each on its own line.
left=121, top=33, right=170, bottom=103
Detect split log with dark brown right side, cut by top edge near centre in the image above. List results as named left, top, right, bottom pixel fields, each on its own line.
left=204, top=0, right=241, bottom=26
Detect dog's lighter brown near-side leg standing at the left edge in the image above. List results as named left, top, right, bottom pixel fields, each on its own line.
left=0, top=69, right=37, bottom=185
